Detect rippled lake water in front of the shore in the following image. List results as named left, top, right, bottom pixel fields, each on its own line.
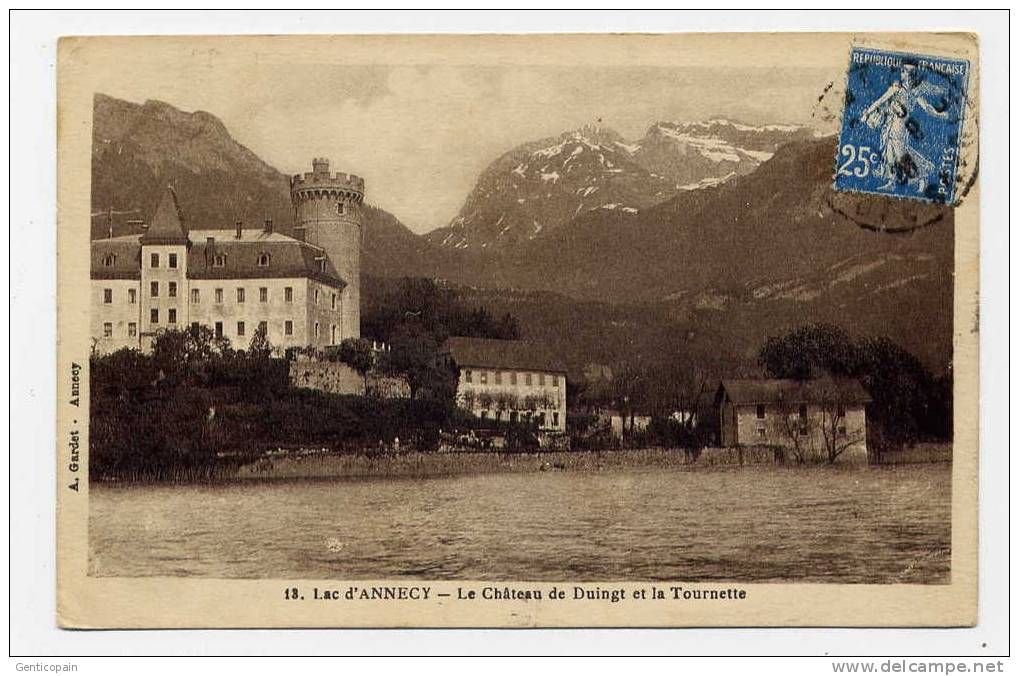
left=90, top=465, right=952, bottom=583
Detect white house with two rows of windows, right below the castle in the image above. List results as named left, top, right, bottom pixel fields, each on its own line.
left=439, top=337, right=567, bottom=432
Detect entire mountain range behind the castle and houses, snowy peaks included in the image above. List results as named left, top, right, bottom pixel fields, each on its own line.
left=92, top=95, right=954, bottom=371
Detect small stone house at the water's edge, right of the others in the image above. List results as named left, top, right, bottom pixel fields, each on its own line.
left=714, top=378, right=870, bottom=462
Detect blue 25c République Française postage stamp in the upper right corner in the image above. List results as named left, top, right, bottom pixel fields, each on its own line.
left=835, top=48, right=969, bottom=204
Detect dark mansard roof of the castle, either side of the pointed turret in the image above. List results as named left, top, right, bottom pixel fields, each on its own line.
left=92, top=228, right=346, bottom=289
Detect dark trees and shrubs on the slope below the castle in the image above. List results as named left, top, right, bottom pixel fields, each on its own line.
left=90, top=326, right=480, bottom=479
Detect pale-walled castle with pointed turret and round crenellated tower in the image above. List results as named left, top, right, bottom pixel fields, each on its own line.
left=91, top=158, right=365, bottom=353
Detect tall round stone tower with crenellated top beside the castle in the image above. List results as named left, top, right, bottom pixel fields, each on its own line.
left=290, top=157, right=365, bottom=340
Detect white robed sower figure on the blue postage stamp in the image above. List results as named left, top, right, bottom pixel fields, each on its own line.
left=860, top=63, right=948, bottom=193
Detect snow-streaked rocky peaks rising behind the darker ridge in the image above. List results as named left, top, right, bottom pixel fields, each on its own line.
left=428, top=119, right=812, bottom=250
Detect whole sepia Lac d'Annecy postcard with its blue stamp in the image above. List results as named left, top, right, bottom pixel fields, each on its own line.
left=56, top=33, right=980, bottom=628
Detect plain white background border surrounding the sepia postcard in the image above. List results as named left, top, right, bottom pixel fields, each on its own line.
left=8, top=11, right=1011, bottom=655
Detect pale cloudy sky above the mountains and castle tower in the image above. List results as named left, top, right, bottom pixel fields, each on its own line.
left=87, top=44, right=837, bottom=232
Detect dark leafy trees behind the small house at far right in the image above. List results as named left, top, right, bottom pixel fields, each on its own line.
left=759, top=323, right=952, bottom=455
